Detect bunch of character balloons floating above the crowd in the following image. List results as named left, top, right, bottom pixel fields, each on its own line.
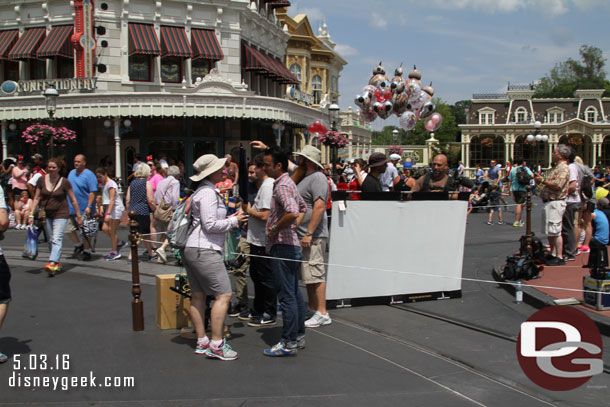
left=354, top=62, right=443, bottom=131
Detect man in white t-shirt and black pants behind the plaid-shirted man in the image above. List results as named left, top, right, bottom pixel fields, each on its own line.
left=246, top=154, right=277, bottom=327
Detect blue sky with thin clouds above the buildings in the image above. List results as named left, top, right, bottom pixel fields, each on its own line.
left=288, top=0, right=610, bottom=128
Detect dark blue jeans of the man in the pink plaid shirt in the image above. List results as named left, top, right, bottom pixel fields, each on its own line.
left=271, top=244, right=305, bottom=348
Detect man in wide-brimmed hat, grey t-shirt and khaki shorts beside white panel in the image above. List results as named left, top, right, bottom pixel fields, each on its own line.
left=294, top=146, right=332, bottom=328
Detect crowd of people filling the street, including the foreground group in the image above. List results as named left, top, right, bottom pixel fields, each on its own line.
left=0, top=141, right=610, bottom=362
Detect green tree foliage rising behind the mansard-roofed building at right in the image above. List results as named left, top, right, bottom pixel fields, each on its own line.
left=534, top=45, right=610, bottom=98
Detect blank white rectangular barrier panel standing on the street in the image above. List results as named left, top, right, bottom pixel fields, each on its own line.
left=326, top=201, right=468, bottom=300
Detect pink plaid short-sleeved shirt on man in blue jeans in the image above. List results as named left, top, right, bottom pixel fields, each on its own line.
left=266, top=172, right=307, bottom=252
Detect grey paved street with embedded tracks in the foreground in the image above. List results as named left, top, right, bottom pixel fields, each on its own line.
left=0, top=199, right=610, bottom=406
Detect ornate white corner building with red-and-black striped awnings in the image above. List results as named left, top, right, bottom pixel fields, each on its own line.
left=0, top=0, right=327, bottom=182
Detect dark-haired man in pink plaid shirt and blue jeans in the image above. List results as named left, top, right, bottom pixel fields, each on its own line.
left=263, top=149, right=307, bottom=356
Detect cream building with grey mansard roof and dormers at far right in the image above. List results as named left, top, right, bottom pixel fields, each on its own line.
left=460, top=85, right=610, bottom=168
